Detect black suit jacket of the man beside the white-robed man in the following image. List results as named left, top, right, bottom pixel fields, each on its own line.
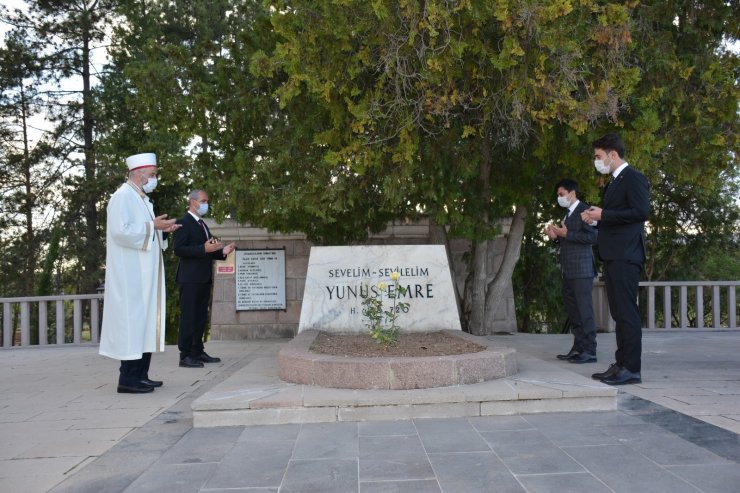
left=175, top=213, right=226, bottom=284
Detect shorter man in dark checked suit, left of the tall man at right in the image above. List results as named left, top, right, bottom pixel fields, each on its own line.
left=545, top=179, right=598, bottom=363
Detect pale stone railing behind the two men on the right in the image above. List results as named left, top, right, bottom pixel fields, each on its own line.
left=593, top=281, right=740, bottom=331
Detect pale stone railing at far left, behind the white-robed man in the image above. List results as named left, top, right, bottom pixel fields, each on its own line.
left=0, top=294, right=103, bottom=349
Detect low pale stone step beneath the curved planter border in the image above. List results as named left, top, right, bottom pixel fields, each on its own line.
left=192, top=337, right=618, bottom=428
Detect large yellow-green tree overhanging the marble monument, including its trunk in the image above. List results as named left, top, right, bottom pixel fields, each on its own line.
left=247, top=1, right=638, bottom=334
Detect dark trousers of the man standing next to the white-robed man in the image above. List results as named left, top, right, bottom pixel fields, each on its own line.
left=177, top=283, right=211, bottom=359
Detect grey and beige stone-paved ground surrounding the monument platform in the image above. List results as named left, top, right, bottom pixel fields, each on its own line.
left=0, top=331, right=740, bottom=493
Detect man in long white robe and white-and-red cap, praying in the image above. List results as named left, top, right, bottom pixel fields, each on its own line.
left=99, top=153, right=179, bottom=394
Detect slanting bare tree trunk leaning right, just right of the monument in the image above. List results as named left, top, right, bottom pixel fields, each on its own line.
left=484, top=205, right=527, bottom=334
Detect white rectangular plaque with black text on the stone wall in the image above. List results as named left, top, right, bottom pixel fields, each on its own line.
left=235, top=249, right=287, bottom=310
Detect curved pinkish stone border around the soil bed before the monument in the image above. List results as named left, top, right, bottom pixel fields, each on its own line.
left=278, top=330, right=517, bottom=390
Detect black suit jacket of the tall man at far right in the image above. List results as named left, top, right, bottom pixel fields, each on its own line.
left=597, top=166, right=650, bottom=264
